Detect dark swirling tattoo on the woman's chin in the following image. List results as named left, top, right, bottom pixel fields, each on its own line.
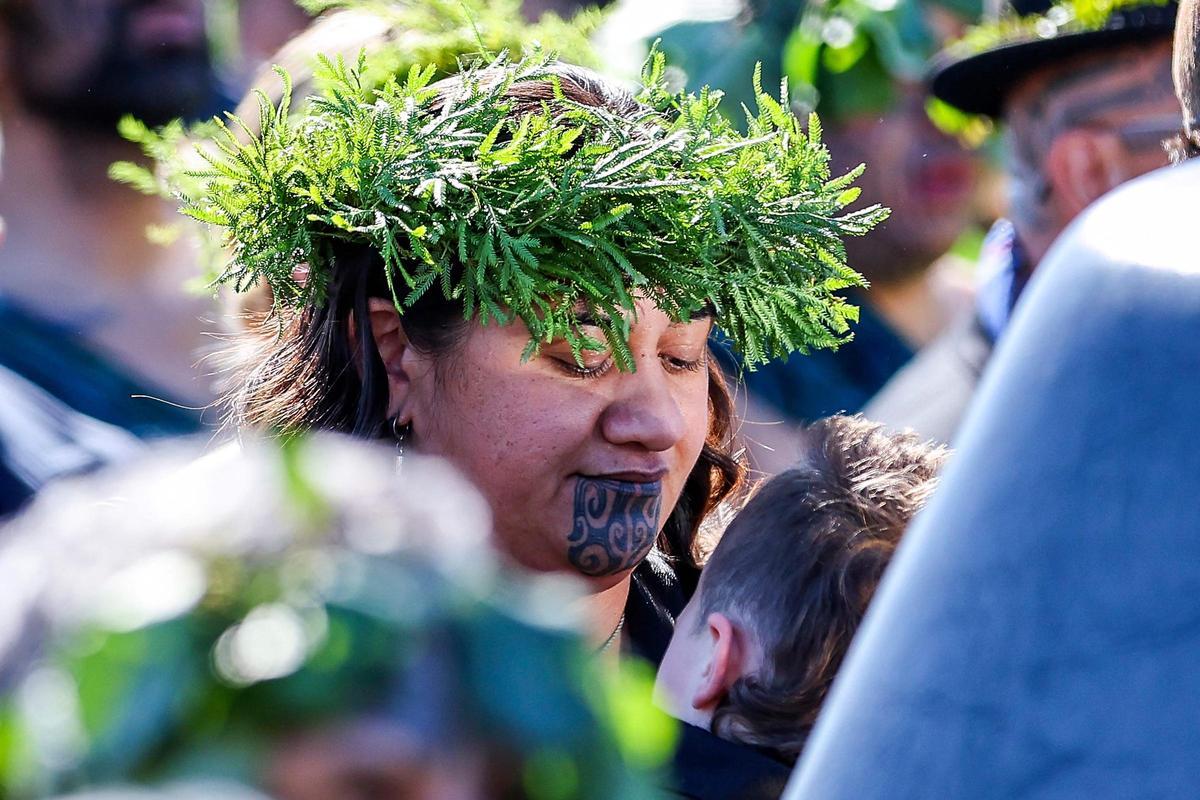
left=566, top=477, right=662, bottom=577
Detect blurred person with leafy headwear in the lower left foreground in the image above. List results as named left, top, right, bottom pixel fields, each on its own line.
left=0, top=434, right=674, bottom=800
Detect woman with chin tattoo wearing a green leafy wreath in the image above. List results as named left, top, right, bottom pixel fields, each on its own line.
left=142, top=51, right=883, bottom=661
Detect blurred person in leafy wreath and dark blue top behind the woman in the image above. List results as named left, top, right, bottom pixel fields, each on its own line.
left=643, top=0, right=979, bottom=473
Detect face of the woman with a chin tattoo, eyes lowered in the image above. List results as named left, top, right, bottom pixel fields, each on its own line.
left=377, top=301, right=712, bottom=585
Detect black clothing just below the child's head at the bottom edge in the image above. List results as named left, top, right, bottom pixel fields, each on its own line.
left=672, top=724, right=792, bottom=800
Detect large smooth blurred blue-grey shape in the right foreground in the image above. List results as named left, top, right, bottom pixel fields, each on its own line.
left=785, top=163, right=1200, bottom=800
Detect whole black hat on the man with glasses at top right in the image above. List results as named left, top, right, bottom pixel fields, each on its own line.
left=930, top=0, right=1178, bottom=119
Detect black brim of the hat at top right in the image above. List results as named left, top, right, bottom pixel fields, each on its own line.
left=929, top=16, right=1175, bottom=119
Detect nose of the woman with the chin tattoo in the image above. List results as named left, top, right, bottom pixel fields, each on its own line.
left=600, top=359, right=686, bottom=452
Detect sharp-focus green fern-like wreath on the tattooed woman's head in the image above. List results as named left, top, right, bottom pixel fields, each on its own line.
left=125, top=54, right=886, bottom=369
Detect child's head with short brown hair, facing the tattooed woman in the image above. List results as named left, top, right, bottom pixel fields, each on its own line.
left=656, top=416, right=946, bottom=758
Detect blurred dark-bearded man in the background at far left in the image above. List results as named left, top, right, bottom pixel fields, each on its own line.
left=0, top=0, right=220, bottom=513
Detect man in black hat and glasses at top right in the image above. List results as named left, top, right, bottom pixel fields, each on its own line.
left=865, top=0, right=1180, bottom=441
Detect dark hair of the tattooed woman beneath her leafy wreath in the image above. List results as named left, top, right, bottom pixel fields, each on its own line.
left=229, top=65, right=744, bottom=573
